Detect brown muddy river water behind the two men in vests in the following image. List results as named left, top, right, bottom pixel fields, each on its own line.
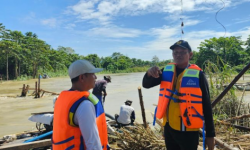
left=0, top=73, right=250, bottom=137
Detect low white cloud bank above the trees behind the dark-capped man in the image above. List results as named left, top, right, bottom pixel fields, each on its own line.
left=110, top=26, right=250, bottom=60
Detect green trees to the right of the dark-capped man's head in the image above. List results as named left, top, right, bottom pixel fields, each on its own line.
left=191, top=35, right=250, bottom=72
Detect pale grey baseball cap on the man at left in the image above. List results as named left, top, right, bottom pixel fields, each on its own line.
left=68, top=59, right=103, bottom=79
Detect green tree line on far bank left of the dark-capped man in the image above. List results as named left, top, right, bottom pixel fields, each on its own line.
left=0, top=23, right=170, bottom=80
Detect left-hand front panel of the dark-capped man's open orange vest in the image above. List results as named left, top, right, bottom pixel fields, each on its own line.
left=156, top=63, right=175, bottom=119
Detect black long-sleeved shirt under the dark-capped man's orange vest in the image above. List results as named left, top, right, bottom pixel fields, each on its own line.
left=142, top=67, right=215, bottom=137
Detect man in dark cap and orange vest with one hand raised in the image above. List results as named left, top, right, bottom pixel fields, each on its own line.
left=143, top=40, right=215, bottom=150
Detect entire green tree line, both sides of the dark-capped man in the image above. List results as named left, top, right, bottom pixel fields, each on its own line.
left=0, top=23, right=250, bottom=80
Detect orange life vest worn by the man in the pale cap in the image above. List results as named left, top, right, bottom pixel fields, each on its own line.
left=52, top=91, right=108, bottom=150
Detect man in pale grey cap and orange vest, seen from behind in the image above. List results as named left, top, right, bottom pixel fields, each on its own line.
left=52, top=60, right=109, bottom=150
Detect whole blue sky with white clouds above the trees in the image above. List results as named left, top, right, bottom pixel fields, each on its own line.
left=0, top=0, right=250, bottom=60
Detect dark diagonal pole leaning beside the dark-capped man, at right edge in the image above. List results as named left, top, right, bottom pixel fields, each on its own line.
left=212, top=63, right=250, bottom=107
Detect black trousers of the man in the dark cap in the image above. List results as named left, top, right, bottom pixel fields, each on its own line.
left=164, top=123, right=199, bottom=150
